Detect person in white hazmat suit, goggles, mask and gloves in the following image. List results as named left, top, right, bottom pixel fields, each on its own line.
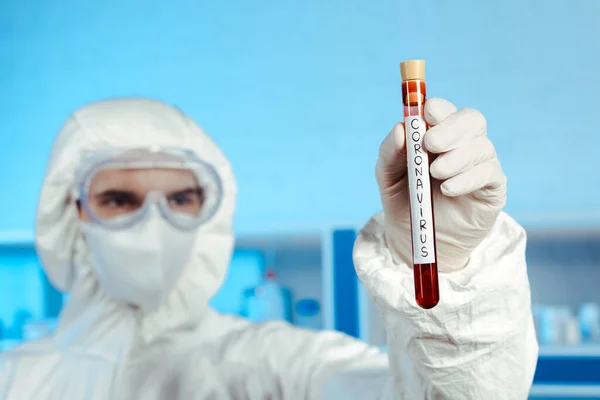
left=0, top=98, right=537, bottom=400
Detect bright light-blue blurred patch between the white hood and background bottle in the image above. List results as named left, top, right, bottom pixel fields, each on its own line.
left=210, top=250, right=265, bottom=315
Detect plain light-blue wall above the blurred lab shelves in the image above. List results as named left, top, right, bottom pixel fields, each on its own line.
left=0, top=0, right=600, bottom=232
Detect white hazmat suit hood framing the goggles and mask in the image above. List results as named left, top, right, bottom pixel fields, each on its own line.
left=36, top=98, right=236, bottom=340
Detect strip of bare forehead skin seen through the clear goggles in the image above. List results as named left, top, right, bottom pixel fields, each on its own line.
left=89, top=168, right=198, bottom=193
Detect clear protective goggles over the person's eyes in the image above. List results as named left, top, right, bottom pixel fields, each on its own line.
left=74, top=148, right=223, bottom=230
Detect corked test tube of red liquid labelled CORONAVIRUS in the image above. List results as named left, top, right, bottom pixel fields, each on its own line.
left=400, top=60, right=440, bottom=309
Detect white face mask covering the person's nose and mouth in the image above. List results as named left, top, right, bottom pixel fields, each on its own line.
left=81, top=205, right=197, bottom=311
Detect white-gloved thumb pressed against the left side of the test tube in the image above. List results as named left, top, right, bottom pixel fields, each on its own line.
left=376, top=122, right=407, bottom=189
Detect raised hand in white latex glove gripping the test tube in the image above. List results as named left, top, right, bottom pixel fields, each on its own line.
left=376, top=99, right=506, bottom=271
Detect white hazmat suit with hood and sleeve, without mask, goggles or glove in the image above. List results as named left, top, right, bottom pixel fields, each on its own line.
left=0, top=99, right=537, bottom=400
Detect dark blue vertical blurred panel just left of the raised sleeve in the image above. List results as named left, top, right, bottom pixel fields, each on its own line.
left=333, top=229, right=358, bottom=337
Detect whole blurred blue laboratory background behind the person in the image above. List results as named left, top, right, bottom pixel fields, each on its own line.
left=0, top=0, right=600, bottom=399
